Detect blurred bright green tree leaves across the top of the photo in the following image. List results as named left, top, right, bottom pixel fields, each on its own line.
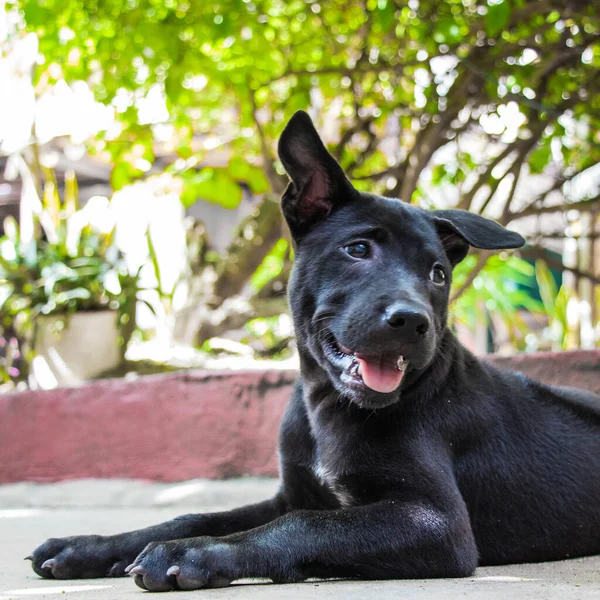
left=19, top=0, right=600, bottom=200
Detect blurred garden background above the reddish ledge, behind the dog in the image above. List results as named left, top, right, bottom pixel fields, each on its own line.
left=0, top=0, right=600, bottom=391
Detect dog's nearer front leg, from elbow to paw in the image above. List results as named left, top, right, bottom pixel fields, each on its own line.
left=129, top=500, right=477, bottom=591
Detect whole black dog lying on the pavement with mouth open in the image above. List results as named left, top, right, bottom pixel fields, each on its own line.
left=29, top=113, right=600, bottom=591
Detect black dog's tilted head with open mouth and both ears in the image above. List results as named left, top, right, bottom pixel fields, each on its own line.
left=279, top=112, right=524, bottom=408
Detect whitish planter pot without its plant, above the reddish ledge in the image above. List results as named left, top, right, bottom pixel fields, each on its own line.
left=31, top=310, right=121, bottom=389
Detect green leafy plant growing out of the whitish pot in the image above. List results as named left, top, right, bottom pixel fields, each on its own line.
left=0, top=174, right=148, bottom=381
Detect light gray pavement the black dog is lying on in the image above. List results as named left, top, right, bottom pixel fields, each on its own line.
left=0, top=479, right=600, bottom=600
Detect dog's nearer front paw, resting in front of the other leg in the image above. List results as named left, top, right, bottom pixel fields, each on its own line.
left=126, top=538, right=236, bottom=592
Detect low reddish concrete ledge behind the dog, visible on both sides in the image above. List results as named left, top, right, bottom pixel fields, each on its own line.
left=0, top=350, right=600, bottom=483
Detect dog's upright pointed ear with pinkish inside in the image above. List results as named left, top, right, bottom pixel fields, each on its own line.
left=278, top=111, right=356, bottom=237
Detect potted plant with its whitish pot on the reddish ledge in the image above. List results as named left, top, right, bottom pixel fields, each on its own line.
left=0, top=174, right=144, bottom=388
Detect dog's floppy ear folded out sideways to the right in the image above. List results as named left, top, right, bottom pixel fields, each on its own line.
left=430, top=209, right=525, bottom=266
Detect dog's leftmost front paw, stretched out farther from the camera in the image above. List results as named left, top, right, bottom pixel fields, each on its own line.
left=27, top=535, right=130, bottom=579
